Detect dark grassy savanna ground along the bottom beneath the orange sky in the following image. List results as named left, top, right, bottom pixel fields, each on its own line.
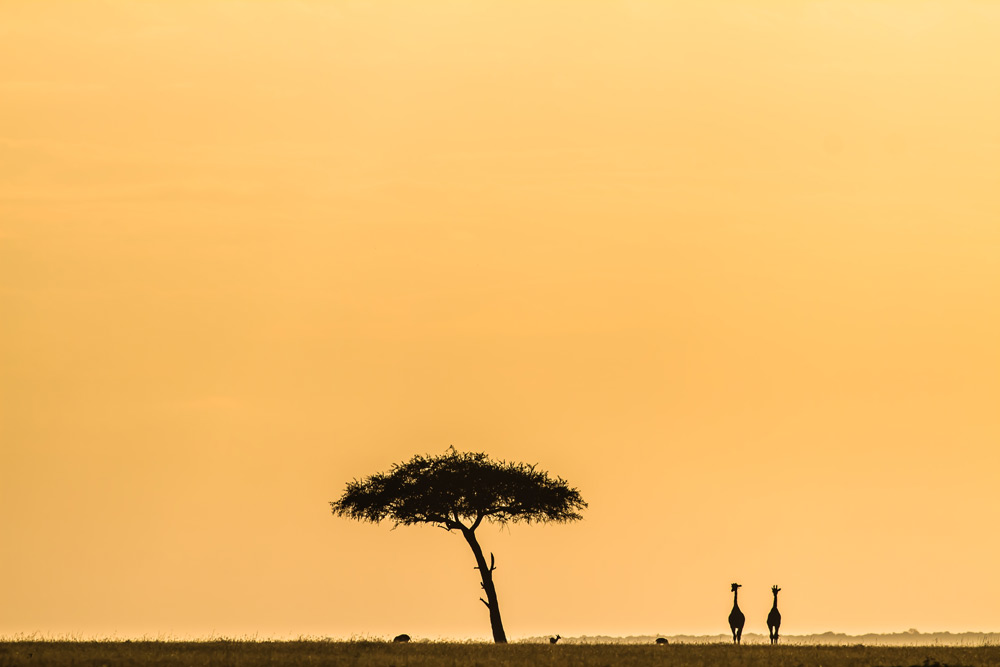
left=0, top=641, right=1000, bottom=667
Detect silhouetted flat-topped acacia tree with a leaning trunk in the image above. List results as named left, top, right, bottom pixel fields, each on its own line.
left=330, top=448, right=587, bottom=644
